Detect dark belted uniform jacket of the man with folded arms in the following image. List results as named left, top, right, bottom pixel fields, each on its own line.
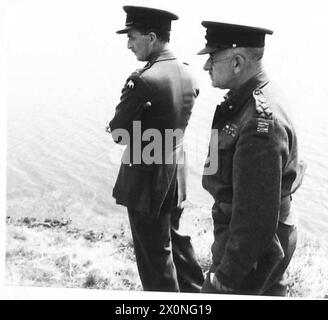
left=109, top=50, right=199, bottom=216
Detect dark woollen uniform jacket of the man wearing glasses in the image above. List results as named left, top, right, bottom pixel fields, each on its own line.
left=203, top=73, right=302, bottom=289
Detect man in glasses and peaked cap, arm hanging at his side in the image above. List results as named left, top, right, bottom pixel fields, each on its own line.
left=199, top=21, right=305, bottom=295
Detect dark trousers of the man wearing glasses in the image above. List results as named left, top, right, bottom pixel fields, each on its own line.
left=201, top=222, right=297, bottom=296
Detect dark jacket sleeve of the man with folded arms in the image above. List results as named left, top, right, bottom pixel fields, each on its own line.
left=109, top=73, right=151, bottom=143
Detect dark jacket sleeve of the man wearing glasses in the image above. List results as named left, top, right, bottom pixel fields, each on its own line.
left=215, top=119, right=288, bottom=289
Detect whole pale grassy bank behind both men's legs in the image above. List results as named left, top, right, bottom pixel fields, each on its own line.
left=6, top=206, right=328, bottom=298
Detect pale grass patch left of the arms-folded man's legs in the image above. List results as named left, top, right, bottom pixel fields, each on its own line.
left=6, top=216, right=141, bottom=290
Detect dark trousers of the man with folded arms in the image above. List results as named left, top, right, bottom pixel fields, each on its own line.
left=128, top=208, right=204, bottom=292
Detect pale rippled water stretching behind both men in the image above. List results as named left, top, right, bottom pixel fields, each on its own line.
left=6, top=1, right=328, bottom=248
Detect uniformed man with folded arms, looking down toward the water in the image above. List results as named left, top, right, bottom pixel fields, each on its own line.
left=107, top=6, right=204, bottom=292
